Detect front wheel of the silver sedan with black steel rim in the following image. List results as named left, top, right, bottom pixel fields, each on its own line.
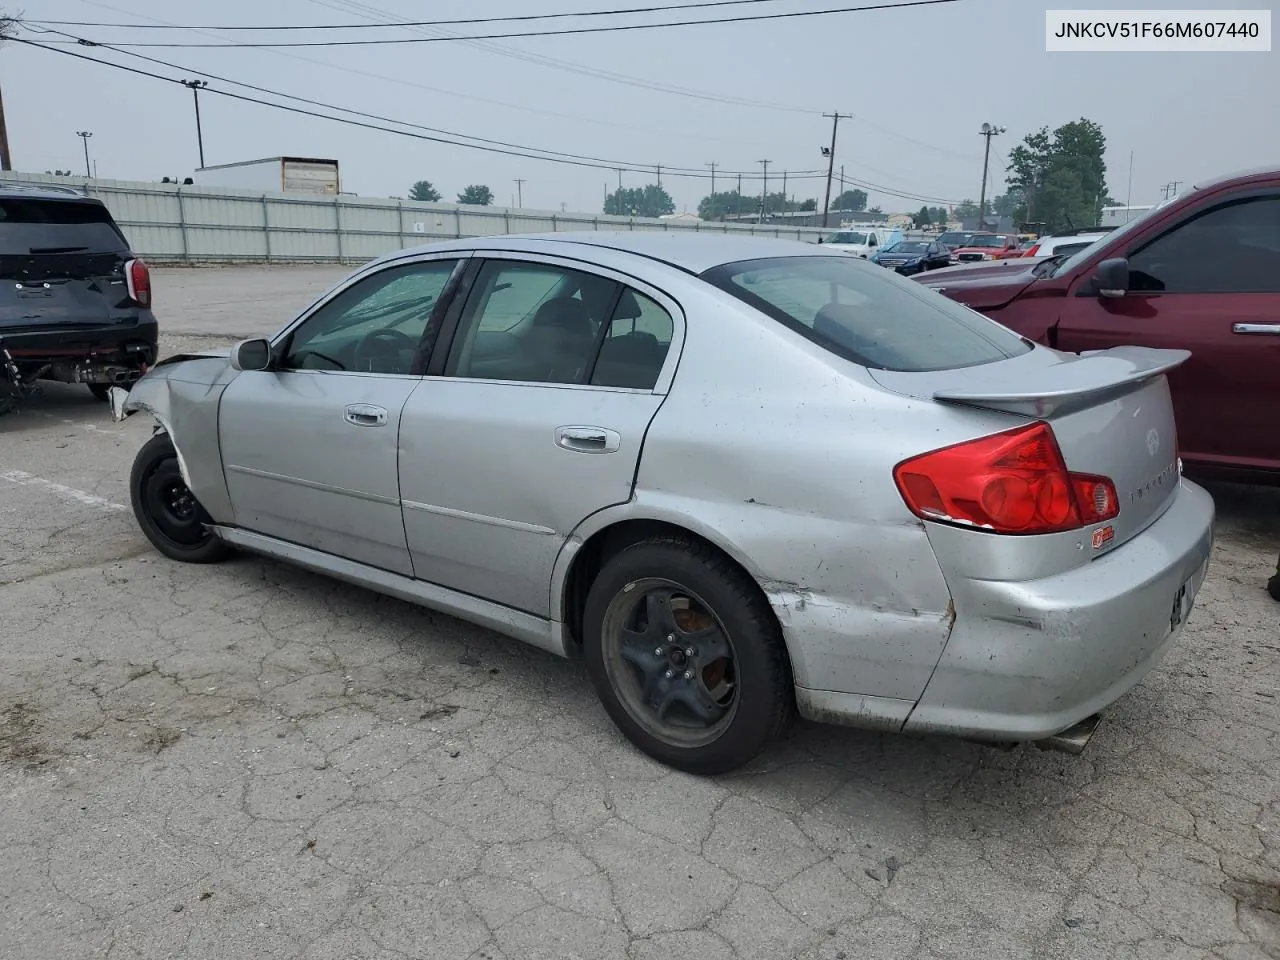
left=129, top=434, right=230, bottom=563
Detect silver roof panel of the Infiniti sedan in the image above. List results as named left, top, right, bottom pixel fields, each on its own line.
left=387, top=230, right=845, bottom=274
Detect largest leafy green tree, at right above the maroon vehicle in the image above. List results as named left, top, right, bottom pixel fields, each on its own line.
left=1005, top=116, right=1108, bottom=230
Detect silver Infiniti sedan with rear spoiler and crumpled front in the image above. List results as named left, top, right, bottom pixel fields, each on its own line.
left=113, top=233, right=1213, bottom=773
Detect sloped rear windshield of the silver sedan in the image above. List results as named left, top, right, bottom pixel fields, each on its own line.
left=703, top=256, right=1030, bottom=372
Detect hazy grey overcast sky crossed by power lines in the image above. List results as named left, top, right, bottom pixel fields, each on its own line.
left=0, top=0, right=1280, bottom=211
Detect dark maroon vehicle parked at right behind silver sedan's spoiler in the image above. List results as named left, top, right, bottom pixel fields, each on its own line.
left=923, top=169, right=1280, bottom=483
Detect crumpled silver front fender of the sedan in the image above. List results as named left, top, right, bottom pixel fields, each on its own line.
left=109, top=353, right=238, bottom=524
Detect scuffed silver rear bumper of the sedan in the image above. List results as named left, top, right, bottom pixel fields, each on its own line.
left=904, top=480, right=1213, bottom=740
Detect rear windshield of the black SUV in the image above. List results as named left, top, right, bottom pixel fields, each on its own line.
left=0, top=197, right=128, bottom=256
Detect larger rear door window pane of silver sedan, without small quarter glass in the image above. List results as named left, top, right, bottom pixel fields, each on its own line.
left=444, top=260, right=620, bottom=384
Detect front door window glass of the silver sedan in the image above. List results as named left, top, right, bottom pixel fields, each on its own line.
left=280, top=260, right=458, bottom=375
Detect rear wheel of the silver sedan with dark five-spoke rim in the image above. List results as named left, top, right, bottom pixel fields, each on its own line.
left=582, top=538, right=794, bottom=774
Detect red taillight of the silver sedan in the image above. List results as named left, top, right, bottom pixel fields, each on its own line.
left=893, top=422, right=1120, bottom=534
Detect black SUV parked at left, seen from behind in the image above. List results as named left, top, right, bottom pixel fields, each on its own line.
left=0, top=183, right=156, bottom=413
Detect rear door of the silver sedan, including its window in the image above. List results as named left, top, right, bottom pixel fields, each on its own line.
left=399, top=257, right=678, bottom=617
